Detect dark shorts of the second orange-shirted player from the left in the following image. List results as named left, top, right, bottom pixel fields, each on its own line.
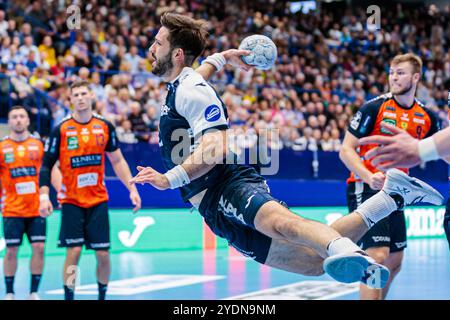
left=58, top=202, right=110, bottom=250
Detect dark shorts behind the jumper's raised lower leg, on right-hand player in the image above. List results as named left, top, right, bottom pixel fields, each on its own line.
left=347, top=182, right=407, bottom=252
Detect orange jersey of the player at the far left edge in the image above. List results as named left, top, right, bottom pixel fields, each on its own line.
left=0, top=136, right=44, bottom=218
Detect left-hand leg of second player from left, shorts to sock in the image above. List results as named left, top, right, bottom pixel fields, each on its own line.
left=58, top=203, right=86, bottom=300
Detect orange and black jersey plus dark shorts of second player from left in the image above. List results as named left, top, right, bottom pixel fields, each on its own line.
left=40, top=114, right=118, bottom=250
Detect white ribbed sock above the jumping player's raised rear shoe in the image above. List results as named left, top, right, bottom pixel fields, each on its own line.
left=355, top=191, right=398, bottom=229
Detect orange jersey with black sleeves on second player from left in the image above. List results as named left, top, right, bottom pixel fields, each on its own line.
left=41, top=114, right=118, bottom=208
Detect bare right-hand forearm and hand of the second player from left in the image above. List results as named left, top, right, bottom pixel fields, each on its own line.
left=106, top=149, right=141, bottom=212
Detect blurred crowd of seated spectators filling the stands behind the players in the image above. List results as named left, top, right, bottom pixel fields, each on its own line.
left=0, top=0, right=450, bottom=151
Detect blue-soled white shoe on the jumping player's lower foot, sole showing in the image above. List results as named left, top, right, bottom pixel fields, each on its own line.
left=323, top=251, right=390, bottom=289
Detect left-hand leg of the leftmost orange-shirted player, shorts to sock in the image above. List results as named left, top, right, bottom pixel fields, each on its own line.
left=3, top=217, right=25, bottom=300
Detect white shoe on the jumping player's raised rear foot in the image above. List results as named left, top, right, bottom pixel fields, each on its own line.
left=382, top=169, right=444, bottom=208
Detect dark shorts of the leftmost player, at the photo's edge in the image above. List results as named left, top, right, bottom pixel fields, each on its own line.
left=3, top=217, right=47, bottom=247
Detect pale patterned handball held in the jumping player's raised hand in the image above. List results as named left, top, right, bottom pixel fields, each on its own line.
left=239, top=34, right=277, bottom=70
